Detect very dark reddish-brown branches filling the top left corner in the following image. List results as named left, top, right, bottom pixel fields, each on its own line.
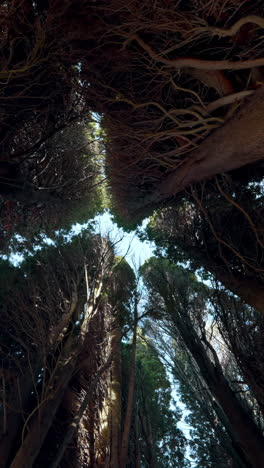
left=0, top=0, right=82, bottom=160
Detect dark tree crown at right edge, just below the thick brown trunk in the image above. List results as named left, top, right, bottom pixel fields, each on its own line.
left=142, top=173, right=264, bottom=312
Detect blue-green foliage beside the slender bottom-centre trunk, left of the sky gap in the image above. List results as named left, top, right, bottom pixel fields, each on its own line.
left=122, top=330, right=188, bottom=468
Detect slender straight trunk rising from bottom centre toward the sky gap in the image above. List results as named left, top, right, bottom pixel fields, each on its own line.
left=120, top=298, right=138, bottom=468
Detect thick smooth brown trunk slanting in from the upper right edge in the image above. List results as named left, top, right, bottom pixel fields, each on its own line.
left=138, top=87, right=264, bottom=212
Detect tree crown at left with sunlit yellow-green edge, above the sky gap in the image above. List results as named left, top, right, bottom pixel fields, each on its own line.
left=0, top=119, right=103, bottom=250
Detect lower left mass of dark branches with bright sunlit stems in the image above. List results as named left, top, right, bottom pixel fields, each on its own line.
left=0, top=234, right=121, bottom=467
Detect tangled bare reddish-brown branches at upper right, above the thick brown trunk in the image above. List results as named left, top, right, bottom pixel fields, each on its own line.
left=72, top=0, right=264, bottom=215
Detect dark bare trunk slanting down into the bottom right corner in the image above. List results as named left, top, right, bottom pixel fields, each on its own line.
left=171, top=309, right=264, bottom=468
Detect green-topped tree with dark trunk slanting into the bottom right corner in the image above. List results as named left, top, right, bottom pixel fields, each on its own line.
left=142, top=258, right=263, bottom=467
